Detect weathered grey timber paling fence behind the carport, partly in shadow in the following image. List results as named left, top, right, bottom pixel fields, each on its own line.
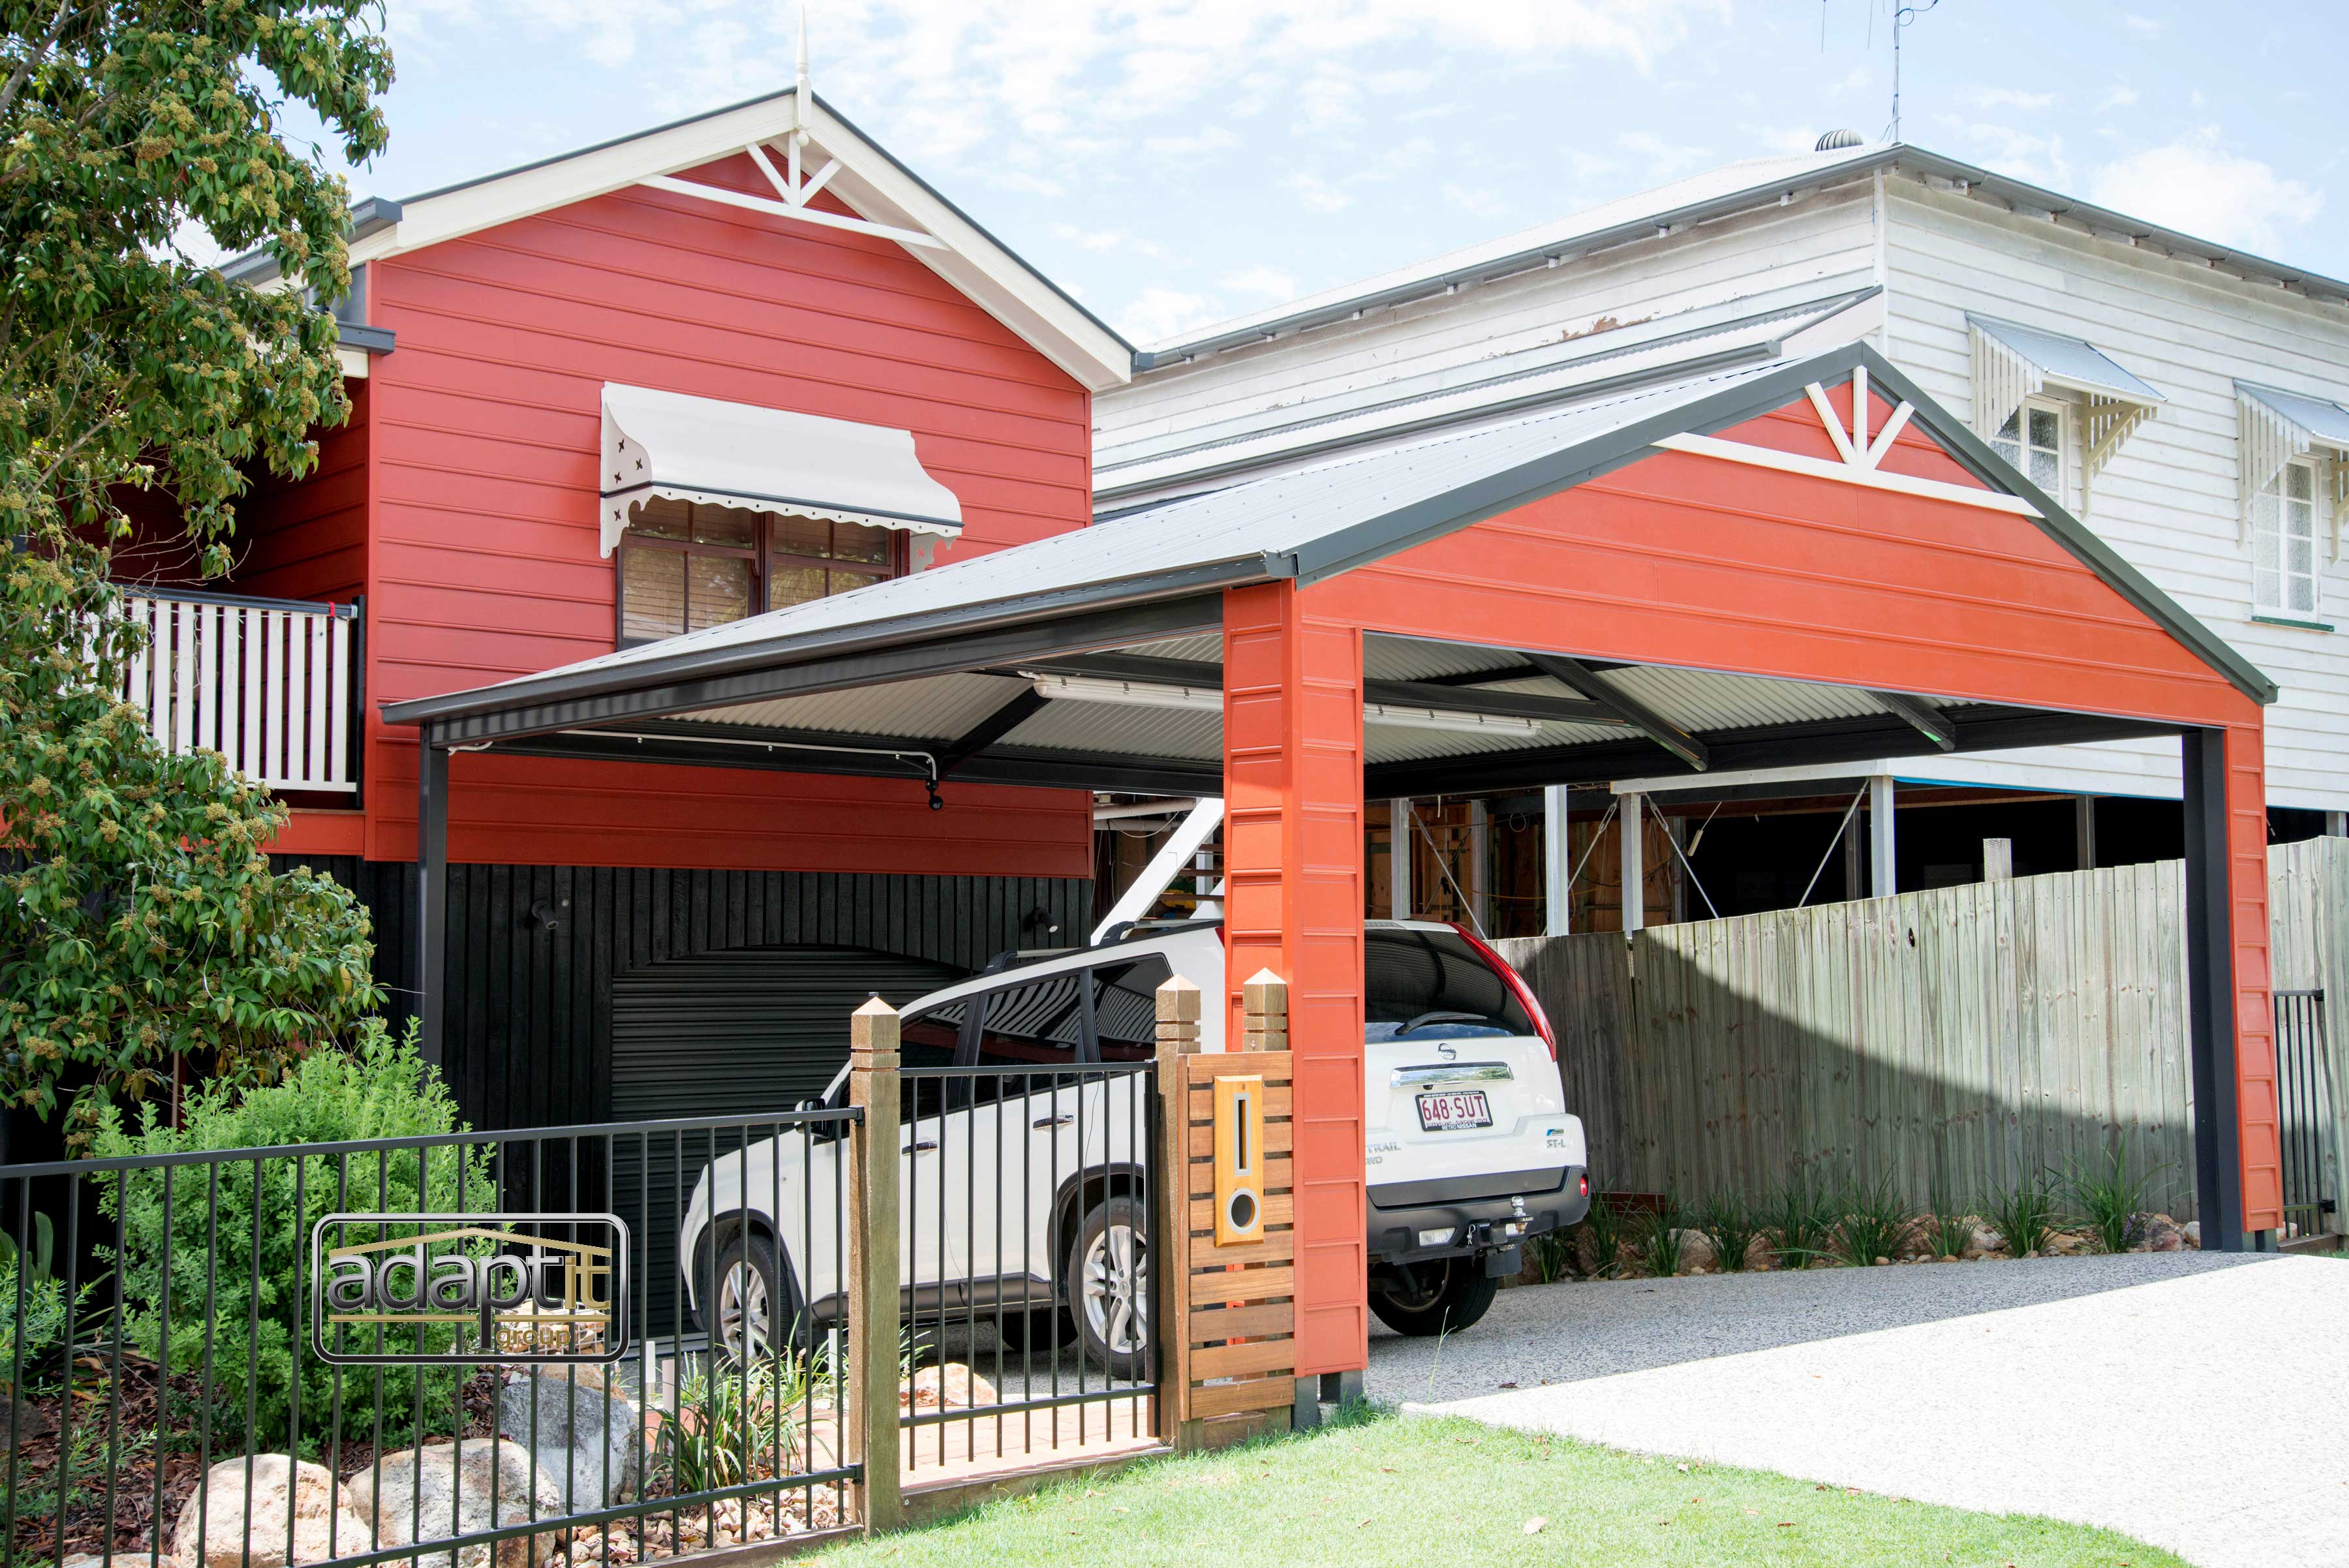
left=1499, top=838, right=2349, bottom=1227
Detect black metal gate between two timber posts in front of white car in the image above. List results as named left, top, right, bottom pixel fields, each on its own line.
left=900, top=1052, right=1167, bottom=1481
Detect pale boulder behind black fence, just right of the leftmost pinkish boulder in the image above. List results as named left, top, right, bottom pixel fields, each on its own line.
left=343, top=1437, right=568, bottom=1568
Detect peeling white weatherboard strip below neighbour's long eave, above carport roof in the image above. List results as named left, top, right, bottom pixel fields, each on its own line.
left=1092, top=183, right=1875, bottom=463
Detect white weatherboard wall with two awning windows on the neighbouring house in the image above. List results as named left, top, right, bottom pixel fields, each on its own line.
left=1886, top=178, right=2349, bottom=810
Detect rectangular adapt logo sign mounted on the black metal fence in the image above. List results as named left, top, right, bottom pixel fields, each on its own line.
left=310, top=1214, right=630, bottom=1366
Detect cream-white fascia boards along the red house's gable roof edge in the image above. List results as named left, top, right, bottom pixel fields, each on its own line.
left=350, top=91, right=1135, bottom=392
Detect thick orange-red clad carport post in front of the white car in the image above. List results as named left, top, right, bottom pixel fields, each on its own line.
left=1224, top=582, right=1370, bottom=1376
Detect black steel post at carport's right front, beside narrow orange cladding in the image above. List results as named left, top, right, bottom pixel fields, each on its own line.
left=2177, top=728, right=2248, bottom=1251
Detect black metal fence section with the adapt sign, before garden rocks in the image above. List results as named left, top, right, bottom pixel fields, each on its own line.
left=0, top=1108, right=862, bottom=1568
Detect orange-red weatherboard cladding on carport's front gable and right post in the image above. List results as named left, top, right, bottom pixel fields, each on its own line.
left=1306, top=403, right=2281, bottom=1230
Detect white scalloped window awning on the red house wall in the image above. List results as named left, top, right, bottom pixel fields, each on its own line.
left=602, top=382, right=963, bottom=557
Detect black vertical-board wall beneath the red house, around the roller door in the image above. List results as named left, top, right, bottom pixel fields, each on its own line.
left=279, top=857, right=1092, bottom=1127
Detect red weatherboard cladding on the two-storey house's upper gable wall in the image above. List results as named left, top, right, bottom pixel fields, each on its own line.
left=352, top=157, right=1092, bottom=876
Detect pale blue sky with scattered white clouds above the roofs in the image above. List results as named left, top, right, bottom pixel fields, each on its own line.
left=279, top=0, right=2349, bottom=345
